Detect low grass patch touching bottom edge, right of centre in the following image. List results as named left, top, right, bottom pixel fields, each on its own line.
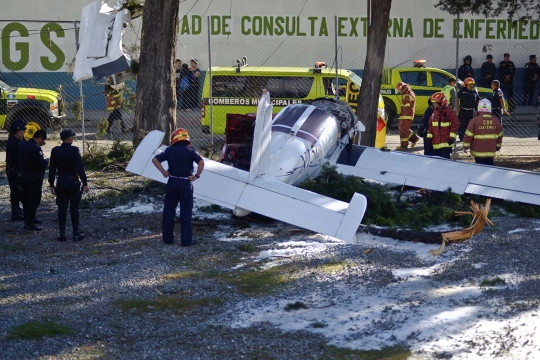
left=320, top=345, right=412, bottom=360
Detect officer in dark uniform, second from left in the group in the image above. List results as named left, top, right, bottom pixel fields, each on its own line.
left=19, top=130, right=49, bottom=231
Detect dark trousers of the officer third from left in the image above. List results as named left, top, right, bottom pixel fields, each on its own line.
left=56, top=177, right=81, bottom=229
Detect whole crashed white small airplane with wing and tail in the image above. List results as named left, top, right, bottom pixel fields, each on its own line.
left=126, top=87, right=540, bottom=240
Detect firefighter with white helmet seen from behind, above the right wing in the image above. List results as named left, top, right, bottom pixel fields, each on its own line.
left=463, top=99, right=503, bottom=165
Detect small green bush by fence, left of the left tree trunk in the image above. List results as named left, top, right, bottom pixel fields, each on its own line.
left=82, top=139, right=134, bottom=170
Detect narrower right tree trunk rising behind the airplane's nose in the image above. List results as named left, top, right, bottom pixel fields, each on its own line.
left=357, top=0, right=392, bottom=146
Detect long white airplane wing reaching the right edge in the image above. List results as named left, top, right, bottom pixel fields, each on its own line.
left=336, top=145, right=540, bottom=205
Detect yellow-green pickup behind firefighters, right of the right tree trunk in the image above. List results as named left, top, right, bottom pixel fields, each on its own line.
left=381, top=67, right=493, bottom=125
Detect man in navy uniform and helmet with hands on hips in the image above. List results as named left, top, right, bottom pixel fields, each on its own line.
left=152, top=129, right=204, bottom=246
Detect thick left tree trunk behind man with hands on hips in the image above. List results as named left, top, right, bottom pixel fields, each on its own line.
left=133, top=0, right=180, bottom=146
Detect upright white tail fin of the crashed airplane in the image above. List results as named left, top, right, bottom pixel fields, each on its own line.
left=249, top=91, right=272, bottom=183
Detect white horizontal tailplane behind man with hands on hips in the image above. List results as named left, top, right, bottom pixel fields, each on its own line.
left=126, top=130, right=367, bottom=241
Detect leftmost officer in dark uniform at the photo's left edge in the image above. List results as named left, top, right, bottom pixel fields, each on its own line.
left=6, top=120, right=26, bottom=221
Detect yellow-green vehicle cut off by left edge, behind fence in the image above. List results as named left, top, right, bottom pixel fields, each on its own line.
left=0, top=80, right=62, bottom=140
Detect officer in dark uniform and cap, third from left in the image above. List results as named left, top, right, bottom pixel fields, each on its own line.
left=49, top=129, right=88, bottom=241
